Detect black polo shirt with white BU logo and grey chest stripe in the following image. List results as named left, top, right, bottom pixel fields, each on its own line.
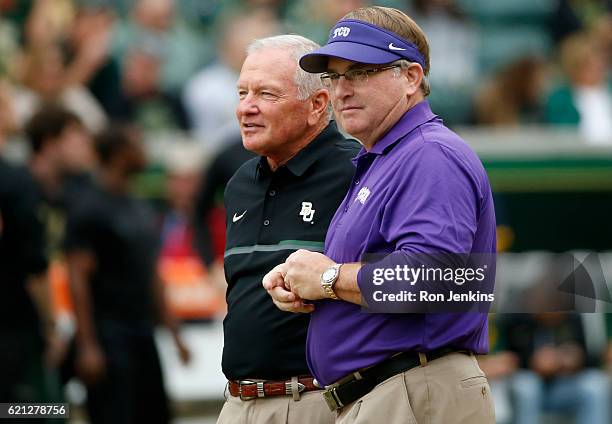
left=223, top=122, right=359, bottom=380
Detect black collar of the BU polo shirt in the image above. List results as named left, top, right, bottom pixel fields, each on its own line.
left=257, top=121, right=338, bottom=177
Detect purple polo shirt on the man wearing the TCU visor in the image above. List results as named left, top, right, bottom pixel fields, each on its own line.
left=306, top=101, right=495, bottom=385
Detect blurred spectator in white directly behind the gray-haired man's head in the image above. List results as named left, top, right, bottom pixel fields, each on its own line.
left=183, top=9, right=279, bottom=150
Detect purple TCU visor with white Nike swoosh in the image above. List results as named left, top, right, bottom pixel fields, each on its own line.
left=300, top=19, right=425, bottom=73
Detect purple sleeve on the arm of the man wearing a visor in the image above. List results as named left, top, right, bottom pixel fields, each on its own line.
left=357, top=142, right=490, bottom=308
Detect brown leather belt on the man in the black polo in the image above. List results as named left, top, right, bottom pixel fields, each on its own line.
left=229, top=376, right=321, bottom=400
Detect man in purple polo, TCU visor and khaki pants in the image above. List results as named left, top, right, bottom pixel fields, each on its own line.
left=263, top=7, right=495, bottom=424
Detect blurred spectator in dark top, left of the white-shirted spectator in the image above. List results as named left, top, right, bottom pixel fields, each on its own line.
left=109, top=45, right=188, bottom=132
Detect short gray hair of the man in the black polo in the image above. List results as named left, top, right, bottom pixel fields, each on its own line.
left=247, top=34, right=325, bottom=100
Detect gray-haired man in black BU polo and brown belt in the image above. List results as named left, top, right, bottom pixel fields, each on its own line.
left=217, top=35, right=357, bottom=424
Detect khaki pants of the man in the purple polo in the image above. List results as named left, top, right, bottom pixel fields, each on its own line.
left=334, top=353, right=495, bottom=424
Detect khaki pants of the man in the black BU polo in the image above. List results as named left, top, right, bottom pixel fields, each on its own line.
left=217, top=391, right=335, bottom=424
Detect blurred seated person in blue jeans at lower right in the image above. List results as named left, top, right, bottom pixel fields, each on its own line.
left=499, top=312, right=610, bottom=424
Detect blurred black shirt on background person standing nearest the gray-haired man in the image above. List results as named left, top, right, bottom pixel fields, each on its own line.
left=64, top=185, right=159, bottom=331
